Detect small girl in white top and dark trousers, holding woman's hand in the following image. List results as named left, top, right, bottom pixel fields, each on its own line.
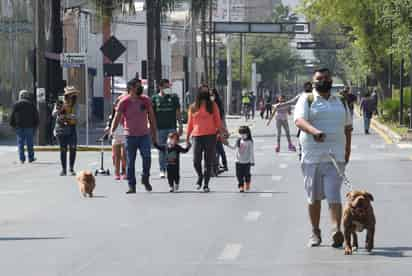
left=226, top=126, right=255, bottom=193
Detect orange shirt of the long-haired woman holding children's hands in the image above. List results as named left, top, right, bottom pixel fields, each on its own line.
left=187, top=103, right=222, bottom=136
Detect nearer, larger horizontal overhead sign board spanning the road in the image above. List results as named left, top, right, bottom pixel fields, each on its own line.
left=214, top=21, right=310, bottom=34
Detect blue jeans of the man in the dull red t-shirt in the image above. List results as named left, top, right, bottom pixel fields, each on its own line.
left=126, top=135, right=152, bottom=188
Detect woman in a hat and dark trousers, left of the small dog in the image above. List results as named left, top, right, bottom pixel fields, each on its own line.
left=52, top=86, right=80, bottom=176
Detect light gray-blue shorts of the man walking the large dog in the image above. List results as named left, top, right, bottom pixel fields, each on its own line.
left=302, top=162, right=345, bottom=204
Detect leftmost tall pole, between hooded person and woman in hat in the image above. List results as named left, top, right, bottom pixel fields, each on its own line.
left=34, top=0, right=49, bottom=145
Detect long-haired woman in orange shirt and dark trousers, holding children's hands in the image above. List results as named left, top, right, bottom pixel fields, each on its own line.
left=186, top=85, right=222, bottom=193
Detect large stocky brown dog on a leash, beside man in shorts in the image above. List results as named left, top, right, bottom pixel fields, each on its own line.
left=343, top=191, right=376, bottom=255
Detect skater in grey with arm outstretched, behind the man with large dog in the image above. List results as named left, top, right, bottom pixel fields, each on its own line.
left=267, top=95, right=296, bottom=153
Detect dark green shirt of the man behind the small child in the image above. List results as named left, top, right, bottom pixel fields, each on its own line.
left=152, top=94, right=180, bottom=129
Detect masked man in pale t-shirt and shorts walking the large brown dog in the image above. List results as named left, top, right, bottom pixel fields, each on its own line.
left=294, top=69, right=353, bottom=247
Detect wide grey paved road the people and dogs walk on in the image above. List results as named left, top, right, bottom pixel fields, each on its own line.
left=0, top=117, right=412, bottom=276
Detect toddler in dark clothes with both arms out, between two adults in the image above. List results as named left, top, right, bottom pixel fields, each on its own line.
left=154, top=132, right=191, bottom=193
